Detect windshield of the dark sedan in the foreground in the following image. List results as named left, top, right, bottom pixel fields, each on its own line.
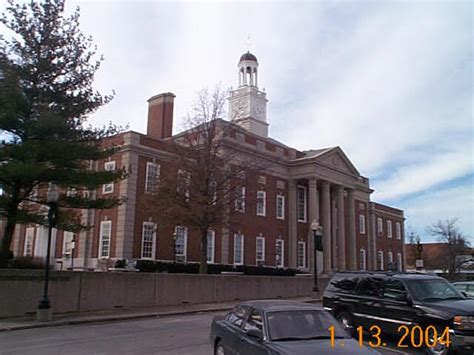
left=266, top=310, right=349, bottom=341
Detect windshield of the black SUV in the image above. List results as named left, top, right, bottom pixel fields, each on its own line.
left=407, top=279, right=465, bottom=302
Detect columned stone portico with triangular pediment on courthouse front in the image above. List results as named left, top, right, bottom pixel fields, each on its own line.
left=289, top=147, right=372, bottom=274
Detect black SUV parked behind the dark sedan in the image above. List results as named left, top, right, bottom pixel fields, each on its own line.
left=323, top=272, right=474, bottom=354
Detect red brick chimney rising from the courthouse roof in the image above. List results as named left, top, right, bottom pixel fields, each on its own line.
left=146, top=92, right=175, bottom=139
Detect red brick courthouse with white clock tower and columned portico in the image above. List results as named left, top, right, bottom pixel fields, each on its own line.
left=12, top=53, right=405, bottom=274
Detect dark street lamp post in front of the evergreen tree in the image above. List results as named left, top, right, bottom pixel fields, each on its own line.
left=36, top=187, right=59, bottom=322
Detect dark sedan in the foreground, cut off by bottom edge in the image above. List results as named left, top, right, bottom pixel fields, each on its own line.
left=210, top=300, right=380, bottom=355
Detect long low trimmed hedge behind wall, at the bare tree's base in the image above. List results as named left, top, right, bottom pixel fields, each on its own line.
left=136, top=260, right=301, bottom=276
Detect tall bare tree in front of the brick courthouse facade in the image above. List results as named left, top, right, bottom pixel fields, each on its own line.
left=149, top=87, right=271, bottom=273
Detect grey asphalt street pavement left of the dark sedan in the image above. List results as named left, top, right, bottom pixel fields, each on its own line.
left=0, top=312, right=422, bottom=355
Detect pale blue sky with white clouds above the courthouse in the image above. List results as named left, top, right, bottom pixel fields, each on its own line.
left=0, top=0, right=474, bottom=244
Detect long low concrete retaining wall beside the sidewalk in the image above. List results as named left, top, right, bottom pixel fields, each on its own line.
left=0, top=270, right=327, bottom=318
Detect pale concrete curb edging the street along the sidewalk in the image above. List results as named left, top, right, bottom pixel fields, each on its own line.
left=0, top=299, right=320, bottom=333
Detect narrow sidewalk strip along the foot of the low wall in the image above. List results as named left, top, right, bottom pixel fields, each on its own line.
left=0, top=297, right=320, bottom=332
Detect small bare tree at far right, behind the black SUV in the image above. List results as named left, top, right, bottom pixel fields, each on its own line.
left=427, top=218, right=469, bottom=274
